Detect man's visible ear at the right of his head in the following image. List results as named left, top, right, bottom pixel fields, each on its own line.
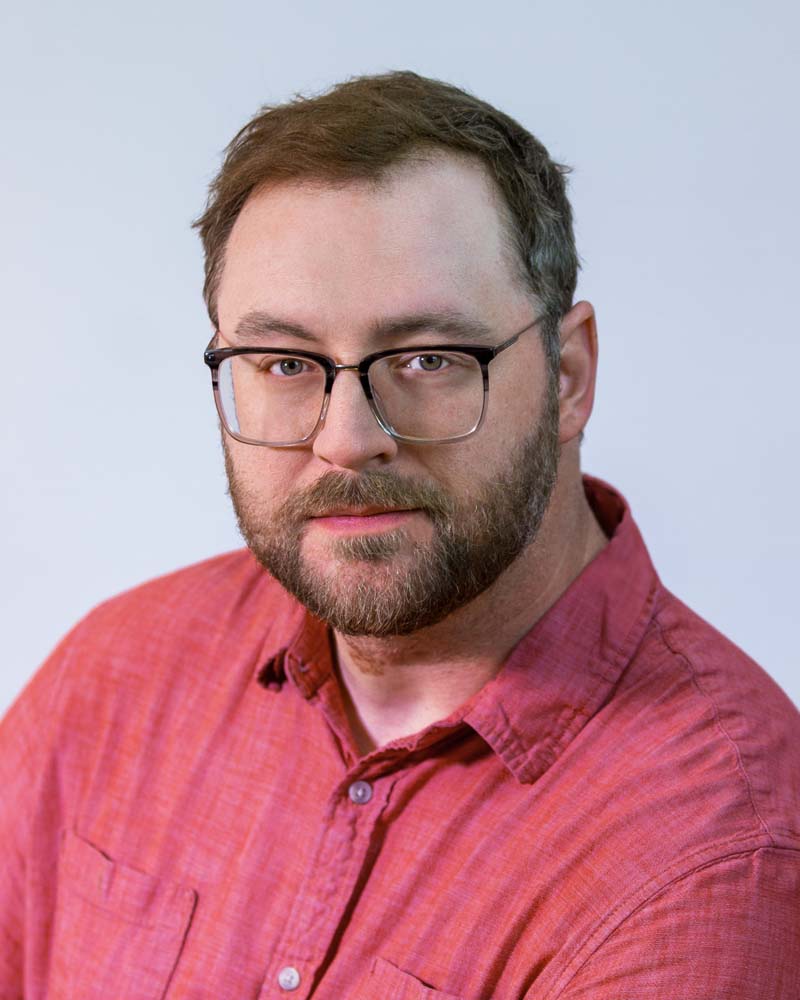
left=558, top=302, right=597, bottom=444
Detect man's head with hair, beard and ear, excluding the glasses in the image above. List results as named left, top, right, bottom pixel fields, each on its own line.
left=192, top=74, right=594, bottom=635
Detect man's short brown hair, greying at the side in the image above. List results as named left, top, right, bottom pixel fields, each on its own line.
left=194, top=72, right=579, bottom=370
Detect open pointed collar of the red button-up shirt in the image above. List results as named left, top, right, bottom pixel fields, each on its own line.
left=258, top=476, right=660, bottom=783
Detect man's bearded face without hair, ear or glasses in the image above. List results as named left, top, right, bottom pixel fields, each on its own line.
left=218, top=157, right=559, bottom=636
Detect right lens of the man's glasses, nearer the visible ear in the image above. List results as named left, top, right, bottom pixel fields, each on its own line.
left=369, top=351, right=483, bottom=441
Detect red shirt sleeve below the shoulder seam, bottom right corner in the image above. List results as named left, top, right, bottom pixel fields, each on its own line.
left=554, top=847, right=800, bottom=1000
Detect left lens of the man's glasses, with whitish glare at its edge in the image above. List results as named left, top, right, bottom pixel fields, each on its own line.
left=218, top=354, right=325, bottom=445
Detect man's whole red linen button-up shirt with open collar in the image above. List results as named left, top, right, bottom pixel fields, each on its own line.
left=0, top=477, right=800, bottom=1000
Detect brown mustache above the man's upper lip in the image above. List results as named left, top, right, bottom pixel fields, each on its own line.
left=280, top=470, right=454, bottom=521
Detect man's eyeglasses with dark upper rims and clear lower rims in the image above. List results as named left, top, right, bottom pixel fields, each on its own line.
left=203, top=317, right=541, bottom=448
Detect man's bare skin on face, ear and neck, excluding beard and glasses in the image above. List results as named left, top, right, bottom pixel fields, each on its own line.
left=218, top=155, right=607, bottom=753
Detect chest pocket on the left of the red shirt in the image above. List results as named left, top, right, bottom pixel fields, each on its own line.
left=47, top=831, right=197, bottom=1000
